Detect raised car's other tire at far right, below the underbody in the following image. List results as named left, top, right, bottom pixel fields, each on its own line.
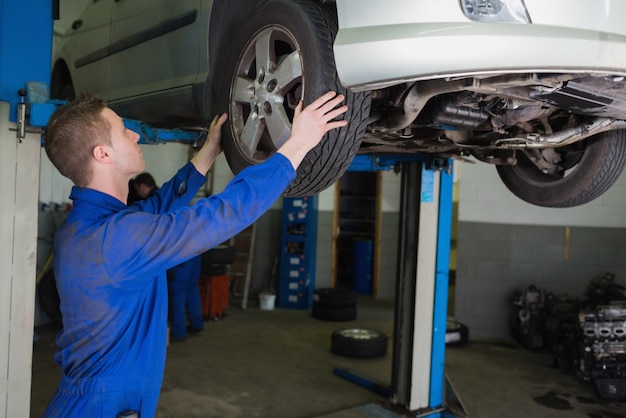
left=496, top=130, right=626, bottom=208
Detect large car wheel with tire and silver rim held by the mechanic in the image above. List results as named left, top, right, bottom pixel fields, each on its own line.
left=212, top=0, right=370, bottom=197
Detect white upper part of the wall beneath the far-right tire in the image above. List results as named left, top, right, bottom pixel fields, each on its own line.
left=457, top=158, right=626, bottom=228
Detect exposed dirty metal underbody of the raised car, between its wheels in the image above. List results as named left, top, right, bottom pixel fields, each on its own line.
left=361, top=73, right=626, bottom=155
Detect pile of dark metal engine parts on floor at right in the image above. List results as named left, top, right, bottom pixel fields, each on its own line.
left=511, top=273, right=626, bottom=401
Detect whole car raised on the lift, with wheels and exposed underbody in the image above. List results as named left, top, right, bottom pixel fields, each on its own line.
left=51, top=0, right=626, bottom=207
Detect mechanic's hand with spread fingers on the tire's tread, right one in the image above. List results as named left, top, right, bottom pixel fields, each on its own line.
left=278, top=91, right=348, bottom=169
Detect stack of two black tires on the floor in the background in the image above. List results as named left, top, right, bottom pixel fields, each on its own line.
left=311, top=288, right=358, bottom=322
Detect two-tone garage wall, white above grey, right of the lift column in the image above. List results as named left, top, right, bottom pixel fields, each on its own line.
left=455, top=163, right=626, bottom=338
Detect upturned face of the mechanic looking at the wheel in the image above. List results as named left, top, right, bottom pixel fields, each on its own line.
left=102, top=108, right=146, bottom=178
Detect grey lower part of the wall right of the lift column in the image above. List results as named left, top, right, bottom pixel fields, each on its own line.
left=455, top=222, right=626, bottom=338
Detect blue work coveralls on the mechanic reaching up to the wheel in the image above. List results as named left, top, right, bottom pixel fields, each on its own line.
left=44, top=153, right=295, bottom=418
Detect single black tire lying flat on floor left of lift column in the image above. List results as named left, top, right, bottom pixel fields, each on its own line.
left=330, top=328, right=389, bottom=358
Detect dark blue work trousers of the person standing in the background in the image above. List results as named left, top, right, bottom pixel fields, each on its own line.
left=167, top=256, right=204, bottom=341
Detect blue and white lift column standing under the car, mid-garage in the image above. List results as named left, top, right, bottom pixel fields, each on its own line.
left=390, top=160, right=453, bottom=417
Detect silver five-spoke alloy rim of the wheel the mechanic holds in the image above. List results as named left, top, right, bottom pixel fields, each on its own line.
left=230, top=26, right=304, bottom=164
